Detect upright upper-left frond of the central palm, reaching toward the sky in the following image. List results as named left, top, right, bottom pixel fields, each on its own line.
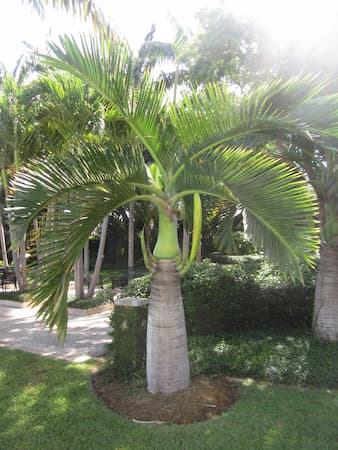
left=44, top=35, right=169, bottom=173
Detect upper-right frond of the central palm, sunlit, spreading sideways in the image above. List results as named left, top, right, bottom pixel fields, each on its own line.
left=170, top=77, right=332, bottom=154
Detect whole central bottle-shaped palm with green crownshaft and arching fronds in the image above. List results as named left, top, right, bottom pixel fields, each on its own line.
left=11, top=36, right=324, bottom=393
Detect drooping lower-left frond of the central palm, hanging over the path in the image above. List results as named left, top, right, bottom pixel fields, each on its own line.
left=9, top=147, right=148, bottom=337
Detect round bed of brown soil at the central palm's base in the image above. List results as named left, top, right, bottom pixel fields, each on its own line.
left=93, top=373, right=239, bottom=425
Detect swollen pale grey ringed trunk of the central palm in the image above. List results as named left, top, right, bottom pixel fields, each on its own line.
left=147, top=259, right=190, bottom=394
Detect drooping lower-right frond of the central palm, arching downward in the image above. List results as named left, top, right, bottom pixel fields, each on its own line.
left=175, top=148, right=318, bottom=279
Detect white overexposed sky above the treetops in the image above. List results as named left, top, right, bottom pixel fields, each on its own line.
left=0, top=0, right=338, bottom=70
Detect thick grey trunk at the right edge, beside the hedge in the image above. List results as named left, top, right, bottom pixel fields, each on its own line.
left=313, top=243, right=338, bottom=342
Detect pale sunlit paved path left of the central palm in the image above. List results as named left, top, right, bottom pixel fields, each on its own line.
left=0, top=302, right=111, bottom=362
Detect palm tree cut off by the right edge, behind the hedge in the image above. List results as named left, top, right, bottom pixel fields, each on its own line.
left=270, top=95, right=338, bottom=342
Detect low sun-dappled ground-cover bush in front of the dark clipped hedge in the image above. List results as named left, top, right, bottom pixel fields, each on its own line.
left=189, top=332, right=338, bottom=388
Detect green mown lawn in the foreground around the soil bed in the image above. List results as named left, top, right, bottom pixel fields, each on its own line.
left=0, top=348, right=338, bottom=450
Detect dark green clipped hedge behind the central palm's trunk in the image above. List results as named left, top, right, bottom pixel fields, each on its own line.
left=125, top=261, right=315, bottom=335
